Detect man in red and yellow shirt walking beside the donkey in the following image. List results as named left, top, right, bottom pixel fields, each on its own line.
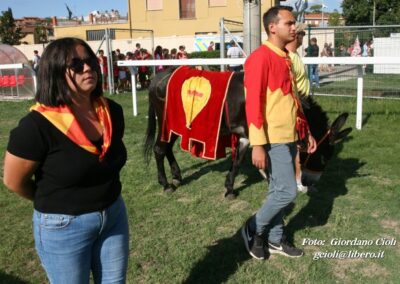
left=242, top=6, right=316, bottom=259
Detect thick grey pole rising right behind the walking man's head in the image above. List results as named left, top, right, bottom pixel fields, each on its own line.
left=243, top=0, right=261, bottom=54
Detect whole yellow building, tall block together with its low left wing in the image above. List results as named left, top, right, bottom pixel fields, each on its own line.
left=54, top=0, right=280, bottom=41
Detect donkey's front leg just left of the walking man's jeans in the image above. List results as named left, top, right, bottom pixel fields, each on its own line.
left=225, top=137, right=249, bottom=199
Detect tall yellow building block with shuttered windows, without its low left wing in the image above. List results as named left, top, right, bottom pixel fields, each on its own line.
left=130, top=0, right=280, bottom=36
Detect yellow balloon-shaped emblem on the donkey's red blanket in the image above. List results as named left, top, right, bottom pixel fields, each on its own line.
left=181, top=77, right=211, bottom=129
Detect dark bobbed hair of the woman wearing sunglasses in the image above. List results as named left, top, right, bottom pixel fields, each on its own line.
left=35, top=37, right=103, bottom=106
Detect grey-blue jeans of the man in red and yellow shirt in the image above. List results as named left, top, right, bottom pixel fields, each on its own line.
left=253, top=142, right=297, bottom=244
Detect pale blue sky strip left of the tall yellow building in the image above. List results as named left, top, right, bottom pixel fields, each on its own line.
left=0, top=0, right=128, bottom=19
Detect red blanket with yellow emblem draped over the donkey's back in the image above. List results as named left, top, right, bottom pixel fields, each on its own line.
left=161, top=66, right=233, bottom=160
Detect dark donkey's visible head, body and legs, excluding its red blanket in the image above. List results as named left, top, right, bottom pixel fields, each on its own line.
left=144, top=68, right=352, bottom=198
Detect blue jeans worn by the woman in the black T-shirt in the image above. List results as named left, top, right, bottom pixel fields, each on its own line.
left=33, top=196, right=129, bottom=284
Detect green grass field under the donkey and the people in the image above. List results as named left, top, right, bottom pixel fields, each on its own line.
left=0, top=92, right=400, bottom=283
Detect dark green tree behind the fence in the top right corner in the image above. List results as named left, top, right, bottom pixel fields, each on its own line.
left=342, top=0, right=400, bottom=25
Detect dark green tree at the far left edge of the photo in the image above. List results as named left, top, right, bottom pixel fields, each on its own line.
left=0, top=8, right=24, bottom=45
